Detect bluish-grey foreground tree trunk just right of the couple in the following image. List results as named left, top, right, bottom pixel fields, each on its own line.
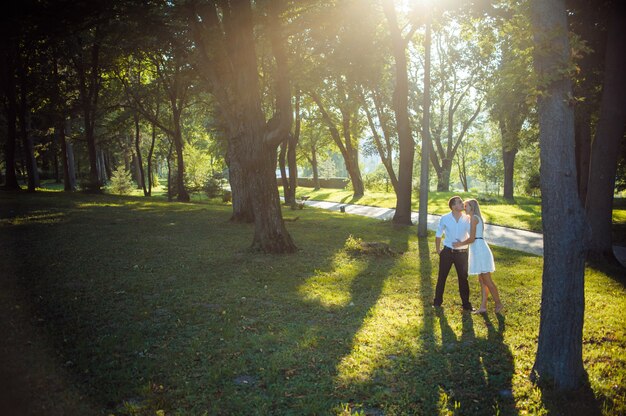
left=531, top=0, right=586, bottom=390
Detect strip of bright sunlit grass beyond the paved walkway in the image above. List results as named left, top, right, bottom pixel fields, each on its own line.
left=297, top=187, right=626, bottom=239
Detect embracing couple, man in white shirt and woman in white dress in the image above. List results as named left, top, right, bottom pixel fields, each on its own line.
left=433, top=196, right=503, bottom=313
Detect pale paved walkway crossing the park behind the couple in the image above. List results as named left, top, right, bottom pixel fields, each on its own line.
left=298, top=200, right=626, bottom=267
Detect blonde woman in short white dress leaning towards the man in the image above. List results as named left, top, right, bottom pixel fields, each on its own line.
left=454, top=199, right=504, bottom=313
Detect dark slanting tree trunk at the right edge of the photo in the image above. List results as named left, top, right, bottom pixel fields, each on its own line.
left=586, top=5, right=626, bottom=263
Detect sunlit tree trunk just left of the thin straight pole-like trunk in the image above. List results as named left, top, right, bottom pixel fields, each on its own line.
left=383, top=0, right=415, bottom=225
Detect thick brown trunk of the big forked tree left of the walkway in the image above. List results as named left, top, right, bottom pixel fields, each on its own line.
left=188, top=0, right=296, bottom=253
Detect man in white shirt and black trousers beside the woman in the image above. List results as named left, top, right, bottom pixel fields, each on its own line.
left=433, top=196, right=474, bottom=312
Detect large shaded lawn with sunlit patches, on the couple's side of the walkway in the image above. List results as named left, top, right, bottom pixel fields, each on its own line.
left=0, top=190, right=626, bottom=415
